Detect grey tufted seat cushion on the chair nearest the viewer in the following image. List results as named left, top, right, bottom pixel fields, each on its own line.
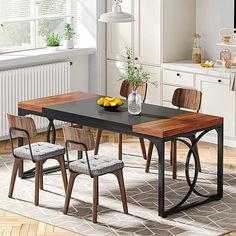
left=70, top=155, right=124, bottom=176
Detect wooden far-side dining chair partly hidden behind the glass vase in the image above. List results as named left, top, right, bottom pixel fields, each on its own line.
left=94, top=81, right=147, bottom=160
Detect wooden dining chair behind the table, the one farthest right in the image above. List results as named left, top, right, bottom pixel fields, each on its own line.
left=145, top=88, right=202, bottom=179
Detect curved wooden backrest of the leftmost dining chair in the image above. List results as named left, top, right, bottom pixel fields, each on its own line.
left=7, top=114, right=37, bottom=138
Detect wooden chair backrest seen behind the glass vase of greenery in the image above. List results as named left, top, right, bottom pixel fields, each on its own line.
left=120, top=81, right=147, bottom=102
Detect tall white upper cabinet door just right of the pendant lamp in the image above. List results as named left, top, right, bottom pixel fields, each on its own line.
left=134, top=0, right=161, bottom=65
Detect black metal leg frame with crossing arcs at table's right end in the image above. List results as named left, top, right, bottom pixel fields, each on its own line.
left=150, top=125, right=223, bottom=217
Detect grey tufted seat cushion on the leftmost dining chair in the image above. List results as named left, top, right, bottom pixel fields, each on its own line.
left=14, top=142, right=65, bottom=161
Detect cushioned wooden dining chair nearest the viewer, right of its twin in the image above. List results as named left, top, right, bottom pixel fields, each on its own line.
left=63, top=127, right=128, bottom=223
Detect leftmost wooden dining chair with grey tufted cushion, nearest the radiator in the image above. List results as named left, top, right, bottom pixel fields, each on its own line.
left=7, top=114, right=68, bottom=206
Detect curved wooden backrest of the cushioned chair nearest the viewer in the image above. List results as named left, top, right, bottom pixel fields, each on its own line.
left=63, top=126, right=95, bottom=151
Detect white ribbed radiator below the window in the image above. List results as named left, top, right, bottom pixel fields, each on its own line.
left=0, top=62, right=70, bottom=139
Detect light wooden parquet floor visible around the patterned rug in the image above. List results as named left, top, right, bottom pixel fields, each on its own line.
left=0, top=131, right=236, bottom=236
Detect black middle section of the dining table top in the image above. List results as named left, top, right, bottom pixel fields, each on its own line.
left=43, top=97, right=187, bottom=135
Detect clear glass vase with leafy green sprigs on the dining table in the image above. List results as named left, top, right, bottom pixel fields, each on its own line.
left=120, top=48, right=157, bottom=115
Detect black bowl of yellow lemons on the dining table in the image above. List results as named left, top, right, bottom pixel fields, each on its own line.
left=97, top=97, right=123, bottom=111
